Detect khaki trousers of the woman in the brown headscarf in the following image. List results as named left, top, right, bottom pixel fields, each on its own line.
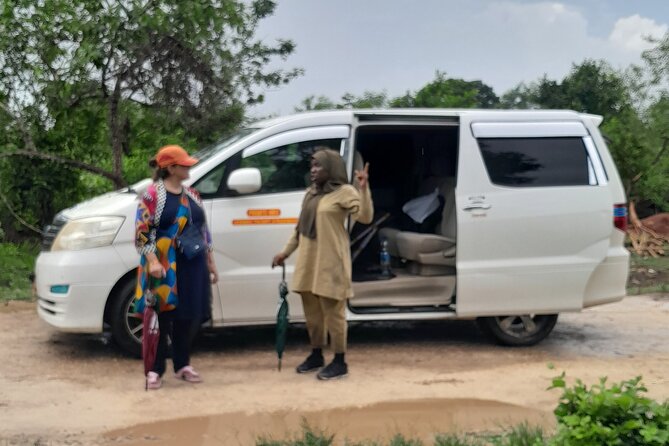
left=300, top=292, right=348, bottom=353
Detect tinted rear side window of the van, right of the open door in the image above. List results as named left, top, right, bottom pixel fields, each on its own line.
left=478, top=137, right=591, bottom=187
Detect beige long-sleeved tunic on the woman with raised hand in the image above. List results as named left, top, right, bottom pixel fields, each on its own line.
left=282, top=184, right=374, bottom=300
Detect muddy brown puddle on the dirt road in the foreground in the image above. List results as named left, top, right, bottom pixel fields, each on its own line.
left=105, top=399, right=554, bottom=446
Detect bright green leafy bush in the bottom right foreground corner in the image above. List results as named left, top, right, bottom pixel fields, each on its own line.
left=550, top=372, right=669, bottom=446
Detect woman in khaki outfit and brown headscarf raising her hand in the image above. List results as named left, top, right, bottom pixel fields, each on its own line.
left=272, top=149, right=374, bottom=379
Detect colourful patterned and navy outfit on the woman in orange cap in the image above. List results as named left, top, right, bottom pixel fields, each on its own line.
left=134, top=180, right=212, bottom=320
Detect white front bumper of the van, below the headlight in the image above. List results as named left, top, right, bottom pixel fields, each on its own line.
left=35, top=246, right=127, bottom=333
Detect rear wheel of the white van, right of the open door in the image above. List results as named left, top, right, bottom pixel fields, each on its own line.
left=476, top=314, right=558, bottom=346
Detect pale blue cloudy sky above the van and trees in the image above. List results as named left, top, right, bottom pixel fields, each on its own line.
left=250, top=0, right=669, bottom=117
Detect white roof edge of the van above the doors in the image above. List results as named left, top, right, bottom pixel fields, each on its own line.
left=249, top=108, right=602, bottom=128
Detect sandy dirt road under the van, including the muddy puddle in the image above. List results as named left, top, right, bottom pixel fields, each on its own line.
left=0, top=295, right=669, bottom=446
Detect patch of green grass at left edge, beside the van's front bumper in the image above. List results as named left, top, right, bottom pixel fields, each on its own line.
left=0, top=242, right=39, bottom=302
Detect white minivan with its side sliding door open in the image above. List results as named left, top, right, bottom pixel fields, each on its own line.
left=35, top=109, right=629, bottom=353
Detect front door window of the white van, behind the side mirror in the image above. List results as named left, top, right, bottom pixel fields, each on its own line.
left=240, top=139, right=341, bottom=194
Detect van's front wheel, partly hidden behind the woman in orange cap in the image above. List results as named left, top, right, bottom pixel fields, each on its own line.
left=110, top=280, right=144, bottom=358
